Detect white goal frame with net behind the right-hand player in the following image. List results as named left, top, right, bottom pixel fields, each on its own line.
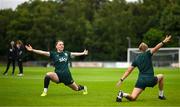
left=127, top=47, right=180, bottom=68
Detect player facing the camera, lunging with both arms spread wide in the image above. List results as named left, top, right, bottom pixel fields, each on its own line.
left=25, top=40, right=88, bottom=96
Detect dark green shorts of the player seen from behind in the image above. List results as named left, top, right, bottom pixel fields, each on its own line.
left=135, top=76, right=158, bottom=90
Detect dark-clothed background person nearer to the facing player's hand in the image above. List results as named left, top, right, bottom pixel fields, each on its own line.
left=16, top=40, right=24, bottom=76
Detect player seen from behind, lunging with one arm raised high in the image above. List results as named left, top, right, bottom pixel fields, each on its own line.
left=116, top=36, right=171, bottom=102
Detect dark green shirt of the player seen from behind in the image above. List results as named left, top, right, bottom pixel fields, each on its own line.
left=132, top=50, right=154, bottom=76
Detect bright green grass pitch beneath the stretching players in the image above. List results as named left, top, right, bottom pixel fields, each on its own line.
left=0, top=67, right=180, bottom=107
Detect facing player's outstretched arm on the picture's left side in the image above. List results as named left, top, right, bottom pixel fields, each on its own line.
left=25, top=45, right=50, bottom=56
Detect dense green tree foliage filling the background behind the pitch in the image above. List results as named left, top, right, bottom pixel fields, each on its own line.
left=0, top=0, right=180, bottom=61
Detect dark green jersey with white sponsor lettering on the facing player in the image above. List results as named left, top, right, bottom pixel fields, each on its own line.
left=50, top=51, right=70, bottom=73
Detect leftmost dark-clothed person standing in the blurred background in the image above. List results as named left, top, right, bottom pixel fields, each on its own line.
left=3, top=41, right=16, bottom=76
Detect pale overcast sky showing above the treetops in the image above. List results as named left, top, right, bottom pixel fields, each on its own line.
left=0, top=0, right=137, bottom=9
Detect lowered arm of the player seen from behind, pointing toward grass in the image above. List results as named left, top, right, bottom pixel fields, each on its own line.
left=116, top=66, right=135, bottom=87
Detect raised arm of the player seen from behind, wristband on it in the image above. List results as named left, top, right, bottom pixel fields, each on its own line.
left=151, top=35, right=171, bottom=54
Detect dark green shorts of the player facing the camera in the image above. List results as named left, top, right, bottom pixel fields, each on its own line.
left=55, top=72, right=74, bottom=85
